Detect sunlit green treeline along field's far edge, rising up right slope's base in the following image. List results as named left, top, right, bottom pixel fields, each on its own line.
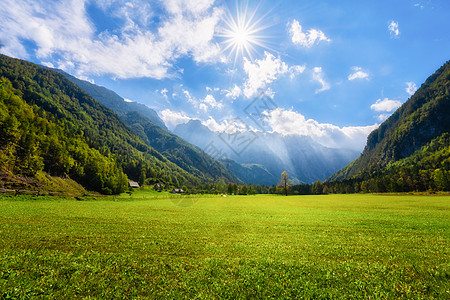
left=168, top=133, right=450, bottom=195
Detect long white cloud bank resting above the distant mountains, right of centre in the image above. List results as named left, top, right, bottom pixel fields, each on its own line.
left=266, top=108, right=378, bottom=151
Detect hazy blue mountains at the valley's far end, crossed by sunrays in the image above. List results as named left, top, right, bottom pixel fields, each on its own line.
left=174, top=120, right=357, bottom=185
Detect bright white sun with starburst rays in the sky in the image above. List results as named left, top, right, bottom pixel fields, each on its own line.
left=216, top=3, right=270, bottom=64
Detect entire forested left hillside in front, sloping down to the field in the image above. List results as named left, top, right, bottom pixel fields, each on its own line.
left=0, top=55, right=201, bottom=194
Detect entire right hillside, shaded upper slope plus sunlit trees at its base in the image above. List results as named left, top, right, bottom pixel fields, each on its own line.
left=328, top=62, right=450, bottom=191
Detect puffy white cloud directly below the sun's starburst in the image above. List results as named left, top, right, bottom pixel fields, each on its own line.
left=244, top=51, right=305, bottom=98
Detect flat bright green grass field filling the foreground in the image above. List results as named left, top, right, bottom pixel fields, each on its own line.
left=0, top=191, right=450, bottom=299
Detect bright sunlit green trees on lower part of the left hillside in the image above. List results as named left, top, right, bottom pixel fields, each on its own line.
left=0, top=77, right=128, bottom=194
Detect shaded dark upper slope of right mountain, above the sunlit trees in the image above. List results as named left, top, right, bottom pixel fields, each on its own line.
left=330, top=62, right=450, bottom=181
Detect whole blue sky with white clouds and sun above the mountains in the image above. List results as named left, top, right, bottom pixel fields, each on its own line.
left=0, top=0, right=450, bottom=149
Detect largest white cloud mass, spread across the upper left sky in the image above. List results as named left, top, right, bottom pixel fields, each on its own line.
left=0, top=0, right=223, bottom=79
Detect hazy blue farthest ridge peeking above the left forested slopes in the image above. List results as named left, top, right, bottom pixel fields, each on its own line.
left=53, top=69, right=167, bottom=129
